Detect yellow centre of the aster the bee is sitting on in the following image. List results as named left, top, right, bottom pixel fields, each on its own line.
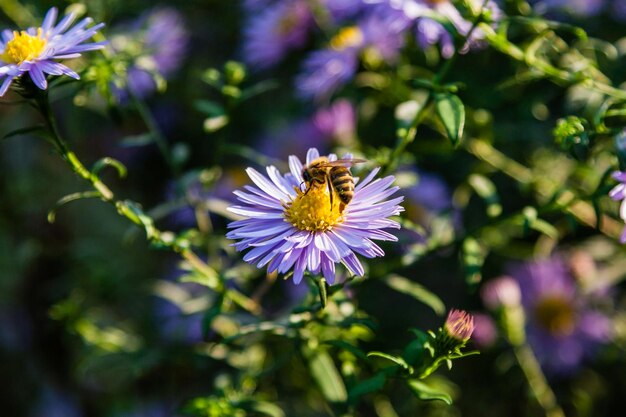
left=283, top=183, right=343, bottom=232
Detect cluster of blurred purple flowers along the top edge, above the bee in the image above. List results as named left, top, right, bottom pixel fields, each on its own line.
left=243, top=0, right=500, bottom=100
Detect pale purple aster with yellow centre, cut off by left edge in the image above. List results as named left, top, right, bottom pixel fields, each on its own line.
left=0, top=7, right=106, bottom=97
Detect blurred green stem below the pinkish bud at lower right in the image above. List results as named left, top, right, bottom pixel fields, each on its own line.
left=513, top=344, right=565, bottom=417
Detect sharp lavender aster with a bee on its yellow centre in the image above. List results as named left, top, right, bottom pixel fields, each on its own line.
left=226, top=148, right=403, bottom=284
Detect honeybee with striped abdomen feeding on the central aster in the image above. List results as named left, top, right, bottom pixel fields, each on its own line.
left=302, top=156, right=366, bottom=211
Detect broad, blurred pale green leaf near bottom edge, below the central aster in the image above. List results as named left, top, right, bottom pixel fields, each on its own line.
left=304, top=349, right=348, bottom=403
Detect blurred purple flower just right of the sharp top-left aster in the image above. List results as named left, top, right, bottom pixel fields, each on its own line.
left=111, top=8, right=189, bottom=100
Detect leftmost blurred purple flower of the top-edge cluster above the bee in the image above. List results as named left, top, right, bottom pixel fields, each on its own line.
left=243, top=0, right=314, bottom=69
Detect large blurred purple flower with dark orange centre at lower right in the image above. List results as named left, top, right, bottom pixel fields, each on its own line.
left=510, top=257, right=611, bottom=374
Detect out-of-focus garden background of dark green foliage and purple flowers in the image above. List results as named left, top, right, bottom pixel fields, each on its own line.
left=0, top=0, right=626, bottom=417
